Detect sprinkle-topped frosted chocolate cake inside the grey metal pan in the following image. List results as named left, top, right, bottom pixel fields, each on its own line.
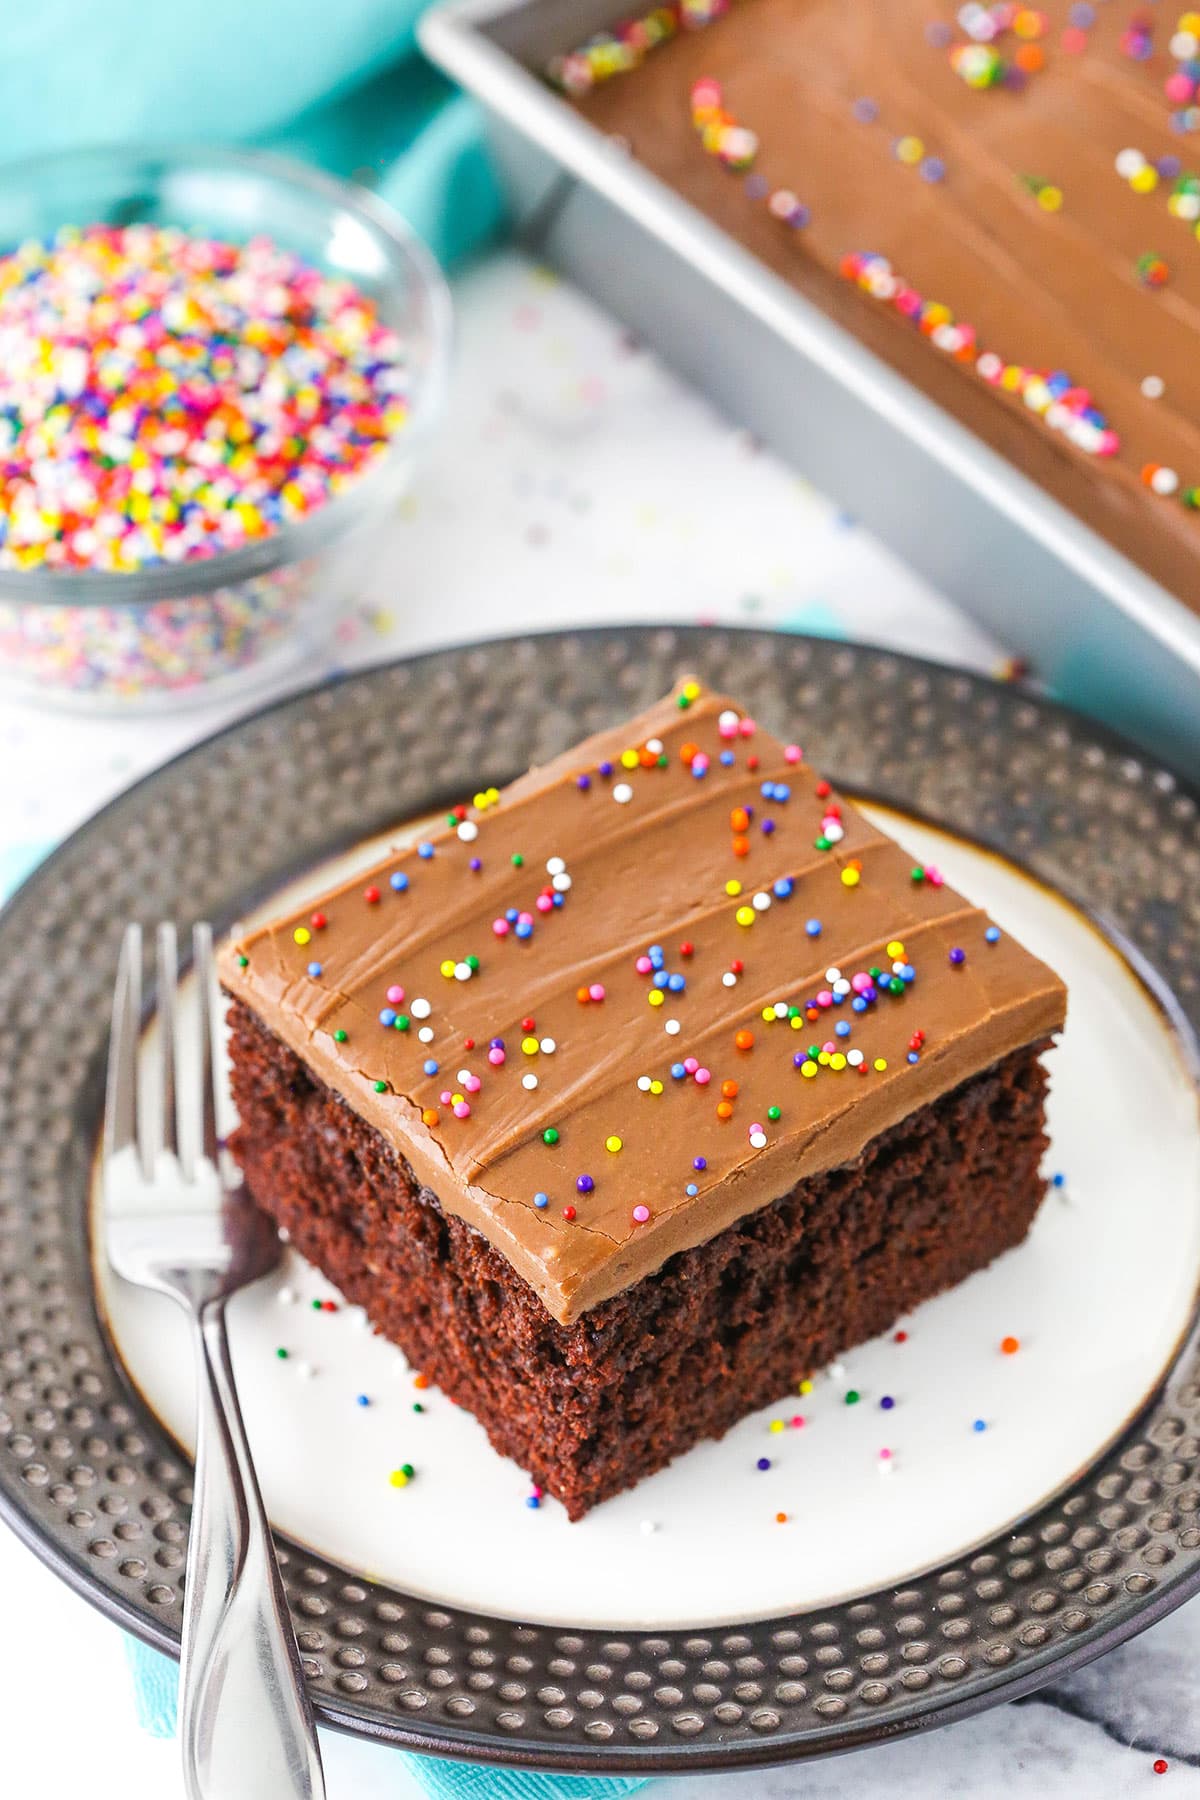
left=551, top=0, right=1200, bottom=554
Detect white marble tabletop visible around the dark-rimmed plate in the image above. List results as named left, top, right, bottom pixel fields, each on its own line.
left=0, top=256, right=1200, bottom=1800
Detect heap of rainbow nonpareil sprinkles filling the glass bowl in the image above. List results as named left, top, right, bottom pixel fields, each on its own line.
left=0, top=225, right=407, bottom=572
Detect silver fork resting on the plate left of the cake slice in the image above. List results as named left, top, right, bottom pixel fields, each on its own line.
left=103, top=925, right=326, bottom=1800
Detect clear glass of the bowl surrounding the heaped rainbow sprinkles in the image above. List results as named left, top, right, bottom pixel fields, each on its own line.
left=0, top=148, right=452, bottom=711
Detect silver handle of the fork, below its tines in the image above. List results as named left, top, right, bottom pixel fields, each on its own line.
left=180, top=1300, right=326, bottom=1800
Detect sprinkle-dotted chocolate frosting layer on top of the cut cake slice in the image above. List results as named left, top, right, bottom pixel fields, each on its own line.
left=219, top=688, right=1065, bottom=1323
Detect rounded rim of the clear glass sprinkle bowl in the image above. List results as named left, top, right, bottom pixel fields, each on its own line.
left=0, top=140, right=453, bottom=607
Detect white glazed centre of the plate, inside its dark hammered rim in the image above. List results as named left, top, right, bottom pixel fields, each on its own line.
left=97, top=808, right=1200, bottom=1629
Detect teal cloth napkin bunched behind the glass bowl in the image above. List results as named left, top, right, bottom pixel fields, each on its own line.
left=0, top=0, right=504, bottom=263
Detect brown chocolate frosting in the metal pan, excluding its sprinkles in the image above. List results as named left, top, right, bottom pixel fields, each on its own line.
left=578, top=0, right=1200, bottom=608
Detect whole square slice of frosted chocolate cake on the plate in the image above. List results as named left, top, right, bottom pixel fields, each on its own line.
left=221, top=684, right=1067, bottom=1517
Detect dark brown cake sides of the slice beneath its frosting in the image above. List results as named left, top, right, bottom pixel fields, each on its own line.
left=230, top=1001, right=1049, bottom=1519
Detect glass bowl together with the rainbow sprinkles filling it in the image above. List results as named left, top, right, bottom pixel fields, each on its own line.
left=0, top=149, right=450, bottom=709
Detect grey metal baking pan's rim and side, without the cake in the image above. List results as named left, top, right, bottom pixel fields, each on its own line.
left=419, top=0, right=1200, bottom=776
